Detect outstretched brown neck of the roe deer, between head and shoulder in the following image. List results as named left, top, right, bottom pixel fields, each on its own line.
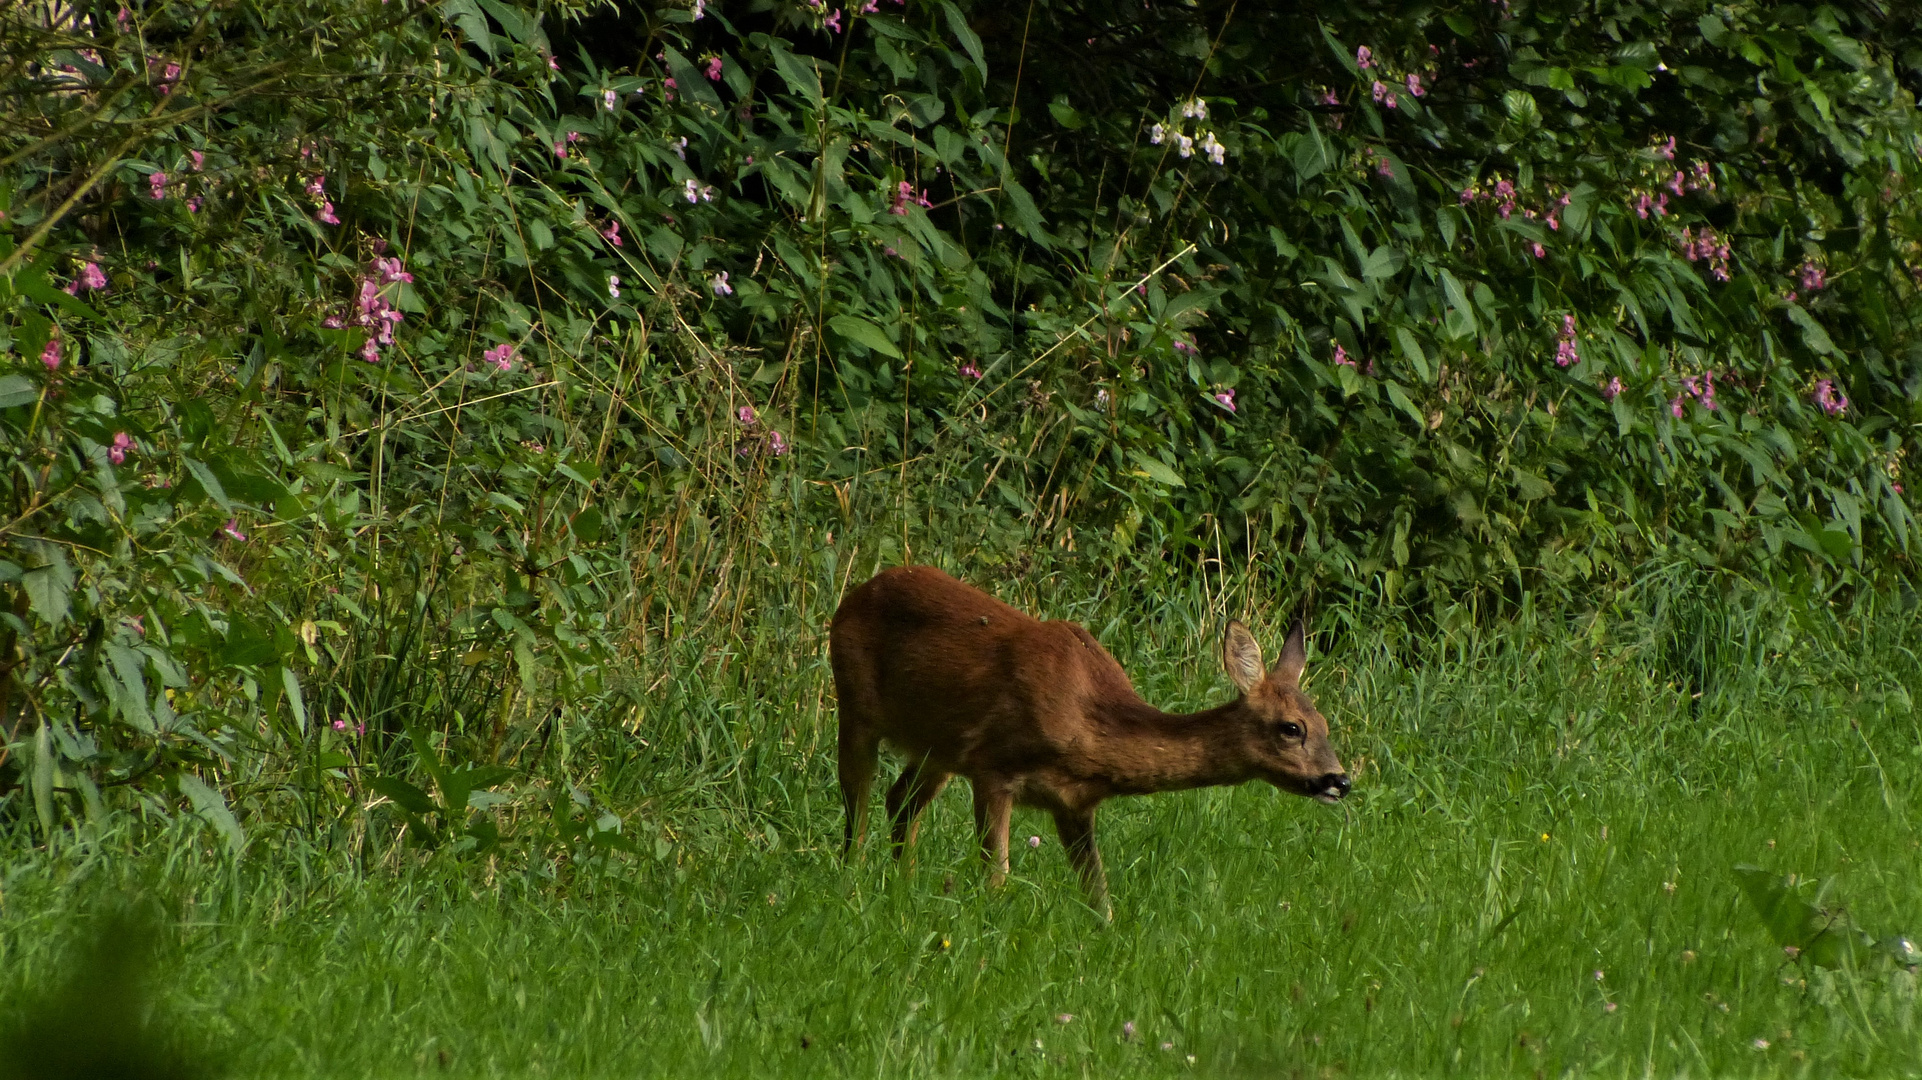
left=1103, top=701, right=1251, bottom=794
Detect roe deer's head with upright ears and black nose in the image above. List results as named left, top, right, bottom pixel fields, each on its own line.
left=1220, top=619, right=1349, bottom=803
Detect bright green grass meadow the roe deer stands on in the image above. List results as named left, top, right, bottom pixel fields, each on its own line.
left=0, top=572, right=1922, bottom=1076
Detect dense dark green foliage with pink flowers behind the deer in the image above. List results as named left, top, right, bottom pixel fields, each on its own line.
left=0, top=0, right=1922, bottom=847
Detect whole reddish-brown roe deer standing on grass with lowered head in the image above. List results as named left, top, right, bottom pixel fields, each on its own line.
left=828, top=567, right=1349, bottom=917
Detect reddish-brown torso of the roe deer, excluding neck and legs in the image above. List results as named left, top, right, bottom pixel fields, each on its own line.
left=828, top=567, right=1138, bottom=776
